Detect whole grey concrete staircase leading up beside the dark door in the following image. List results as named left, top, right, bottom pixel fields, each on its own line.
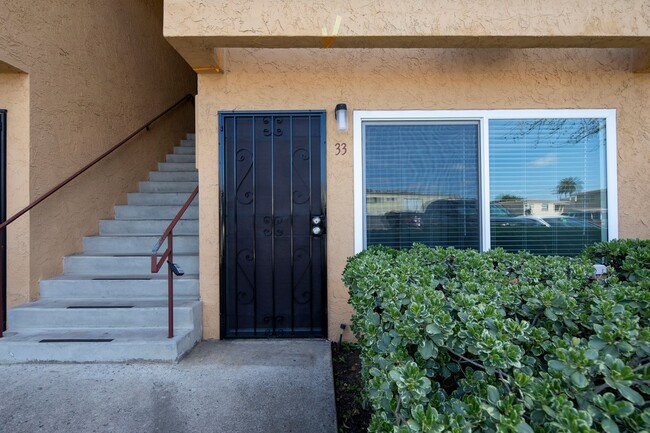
left=0, top=134, right=202, bottom=363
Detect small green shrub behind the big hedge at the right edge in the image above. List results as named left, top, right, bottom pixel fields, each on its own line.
left=583, top=239, right=650, bottom=288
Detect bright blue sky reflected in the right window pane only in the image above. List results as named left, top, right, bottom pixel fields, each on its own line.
left=489, top=119, right=606, bottom=200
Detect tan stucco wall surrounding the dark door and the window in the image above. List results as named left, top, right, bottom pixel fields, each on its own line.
left=197, top=49, right=650, bottom=338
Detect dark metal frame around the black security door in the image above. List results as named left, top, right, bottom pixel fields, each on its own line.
left=218, top=110, right=328, bottom=339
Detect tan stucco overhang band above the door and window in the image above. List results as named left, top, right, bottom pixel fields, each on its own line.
left=164, top=0, right=650, bottom=54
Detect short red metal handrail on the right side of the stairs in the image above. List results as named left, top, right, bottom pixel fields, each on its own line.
left=151, top=186, right=199, bottom=338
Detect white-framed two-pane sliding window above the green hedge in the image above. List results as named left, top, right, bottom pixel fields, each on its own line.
left=354, top=109, right=618, bottom=255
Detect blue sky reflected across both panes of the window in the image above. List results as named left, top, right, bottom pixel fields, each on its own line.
left=364, top=119, right=606, bottom=200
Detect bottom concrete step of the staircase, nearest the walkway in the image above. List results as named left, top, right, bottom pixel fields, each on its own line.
left=0, top=322, right=201, bottom=364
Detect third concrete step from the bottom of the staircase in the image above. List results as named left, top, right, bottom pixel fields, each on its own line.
left=40, top=276, right=199, bottom=300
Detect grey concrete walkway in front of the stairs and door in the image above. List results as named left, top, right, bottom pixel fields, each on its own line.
left=0, top=340, right=336, bottom=433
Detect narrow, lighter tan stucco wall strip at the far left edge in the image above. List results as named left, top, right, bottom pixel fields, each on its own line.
left=0, top=73, right=30, bottom=306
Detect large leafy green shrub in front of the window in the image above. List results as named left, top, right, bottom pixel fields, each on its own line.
left=343, top=245, right=650, bottom=433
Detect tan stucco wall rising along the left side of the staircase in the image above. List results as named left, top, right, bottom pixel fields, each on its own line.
left=0, top=0, right=196, bottom=302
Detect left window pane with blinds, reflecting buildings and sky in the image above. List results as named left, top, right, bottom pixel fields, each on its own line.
left=364, top=122, right=479, bottom=249
